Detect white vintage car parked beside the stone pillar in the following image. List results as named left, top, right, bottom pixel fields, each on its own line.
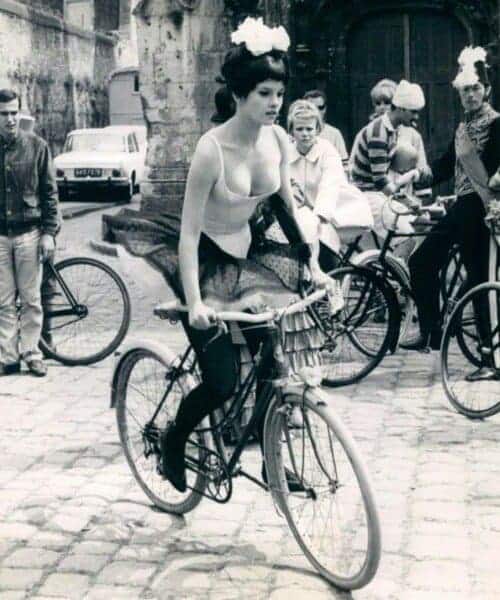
left=54, top=125, right=146, bottom=202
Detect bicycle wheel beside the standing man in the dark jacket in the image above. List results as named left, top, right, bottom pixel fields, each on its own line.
left=40, top=257, right=131, bottom=366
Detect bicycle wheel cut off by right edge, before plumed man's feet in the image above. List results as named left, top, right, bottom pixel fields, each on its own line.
left=441, top=283, right=500, bottom=419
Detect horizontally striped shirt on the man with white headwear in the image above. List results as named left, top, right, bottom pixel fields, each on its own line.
left=350, top=113, right=397, bottom=191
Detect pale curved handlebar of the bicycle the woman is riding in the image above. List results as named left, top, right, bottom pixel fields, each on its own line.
left=153, top=287, right=328, bottom=325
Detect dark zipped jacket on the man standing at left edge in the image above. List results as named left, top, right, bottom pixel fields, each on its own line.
left=0, top=130, right=61, bottom=236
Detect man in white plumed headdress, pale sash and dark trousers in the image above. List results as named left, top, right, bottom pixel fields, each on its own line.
left=401, top=47, right=500, bottom=381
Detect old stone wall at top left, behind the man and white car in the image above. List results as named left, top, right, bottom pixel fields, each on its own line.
left=0, top=0, right=116, bottom=154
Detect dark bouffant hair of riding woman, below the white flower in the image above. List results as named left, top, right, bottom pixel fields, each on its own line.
left=221, top=44, right=290, bottom=98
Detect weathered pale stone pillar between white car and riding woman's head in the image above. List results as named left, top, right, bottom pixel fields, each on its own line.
left=135, top=0, right=231, bottom=212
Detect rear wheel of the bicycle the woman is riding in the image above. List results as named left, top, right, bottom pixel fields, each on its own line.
left=116, top=349, right=207, bottom=515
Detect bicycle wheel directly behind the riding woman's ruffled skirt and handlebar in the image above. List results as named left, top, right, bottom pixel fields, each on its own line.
left=309, top=265, right=399, bottom=387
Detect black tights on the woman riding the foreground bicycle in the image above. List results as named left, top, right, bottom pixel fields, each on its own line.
left=169, top=316, right=272, bottom=446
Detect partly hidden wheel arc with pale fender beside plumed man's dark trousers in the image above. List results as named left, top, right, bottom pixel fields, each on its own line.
left=353, top=250, right=416, bottom=339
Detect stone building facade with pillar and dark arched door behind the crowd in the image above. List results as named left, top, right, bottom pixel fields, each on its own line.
left=135, top=0, right=500, bottom=211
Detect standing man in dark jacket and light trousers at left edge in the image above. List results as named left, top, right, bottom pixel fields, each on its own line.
left=0, top=89, right=60, bottom=377
